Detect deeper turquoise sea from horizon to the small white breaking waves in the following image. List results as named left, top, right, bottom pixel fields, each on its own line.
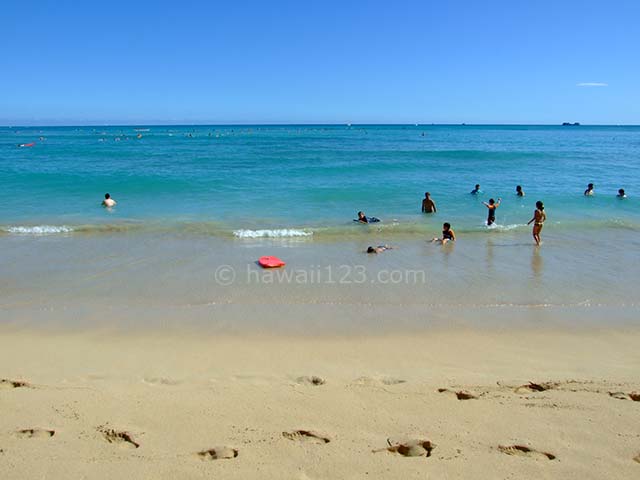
left=0, top=125, right=640, bottom=237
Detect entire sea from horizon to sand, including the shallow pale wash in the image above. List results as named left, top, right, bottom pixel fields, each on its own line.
left=0, top=125, right=640, bottom=332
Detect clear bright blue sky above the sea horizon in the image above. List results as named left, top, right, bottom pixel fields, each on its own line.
left=0, top=0, right=640, bottom=125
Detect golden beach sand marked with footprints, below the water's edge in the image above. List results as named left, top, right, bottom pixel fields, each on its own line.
left=0, top=329, right=640, bottom=479
